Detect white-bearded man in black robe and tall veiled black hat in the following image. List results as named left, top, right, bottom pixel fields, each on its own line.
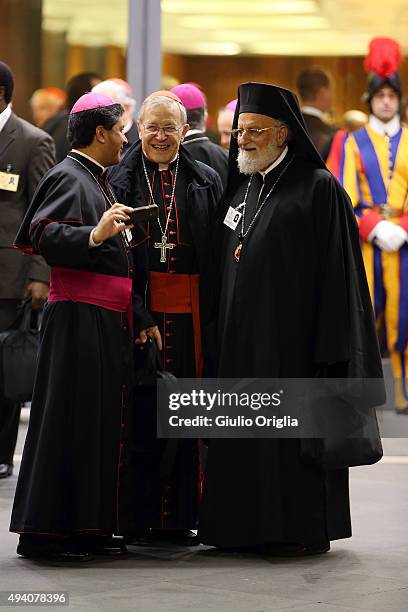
left=198, top=83, right=382, bottom=554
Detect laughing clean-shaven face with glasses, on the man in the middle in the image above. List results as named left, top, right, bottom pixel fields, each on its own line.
left=137, top=100, right=189, bottom=164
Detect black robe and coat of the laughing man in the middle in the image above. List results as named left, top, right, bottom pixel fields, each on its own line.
left=111, top=143, right=222, bottom=530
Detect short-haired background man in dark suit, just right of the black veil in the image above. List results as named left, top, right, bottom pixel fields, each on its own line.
left=297, top=67, right=336, bottom=160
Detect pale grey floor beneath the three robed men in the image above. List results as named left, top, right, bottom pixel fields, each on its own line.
left=0, top=416, right=408, bottom=612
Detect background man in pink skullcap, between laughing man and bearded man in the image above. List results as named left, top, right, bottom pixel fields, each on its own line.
left=171, top=83, right=228, bottom=189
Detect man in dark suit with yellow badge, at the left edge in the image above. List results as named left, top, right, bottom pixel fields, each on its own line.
left=0, top=62, right=55, bottom=478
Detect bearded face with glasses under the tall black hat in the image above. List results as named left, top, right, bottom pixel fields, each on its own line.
left=238, top=113, right=288, bottom=174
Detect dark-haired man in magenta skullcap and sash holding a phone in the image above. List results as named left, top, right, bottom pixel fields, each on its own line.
left=10, top=94, right=134, bottom=560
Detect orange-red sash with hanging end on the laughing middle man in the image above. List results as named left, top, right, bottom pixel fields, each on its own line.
left=150, top=272, right=203, bottom=378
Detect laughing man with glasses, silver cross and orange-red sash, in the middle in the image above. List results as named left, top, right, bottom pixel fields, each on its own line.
left=110, top=91, right=222, bottom=544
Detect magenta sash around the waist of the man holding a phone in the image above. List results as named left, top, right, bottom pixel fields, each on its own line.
left=48, top=267, right=133, bottom=335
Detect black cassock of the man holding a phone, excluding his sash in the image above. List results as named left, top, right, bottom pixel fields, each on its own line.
left=10, top=152, right=134, bottom=536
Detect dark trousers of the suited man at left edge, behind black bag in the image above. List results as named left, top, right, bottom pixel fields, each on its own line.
left=0, top=299, right=21, bottom=465
